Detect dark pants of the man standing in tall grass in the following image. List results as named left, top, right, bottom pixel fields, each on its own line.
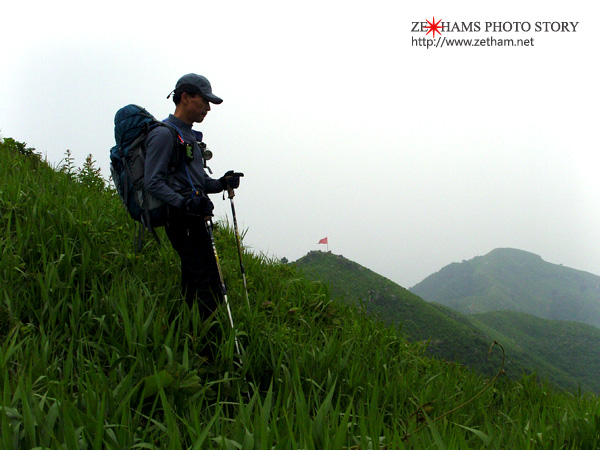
left=165, top=210, right=223, bottom=319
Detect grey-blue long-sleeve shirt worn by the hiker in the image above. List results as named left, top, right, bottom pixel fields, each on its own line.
left=144, top=114, right=223, bottom=208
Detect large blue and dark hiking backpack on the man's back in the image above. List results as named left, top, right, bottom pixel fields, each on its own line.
left=110, top=105, right=183, bottom=241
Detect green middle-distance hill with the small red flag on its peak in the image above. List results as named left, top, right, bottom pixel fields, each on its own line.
left=293, top=251, right=600, bottom=393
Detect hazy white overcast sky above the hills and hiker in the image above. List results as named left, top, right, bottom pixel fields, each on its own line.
left=0, top=0, right=600, bottom=287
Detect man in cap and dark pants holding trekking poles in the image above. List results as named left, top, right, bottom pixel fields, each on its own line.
left=144, top=73, right=241, bottom=319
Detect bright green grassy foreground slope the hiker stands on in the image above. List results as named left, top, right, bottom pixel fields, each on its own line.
left=0, top=139, right=600, bottom=450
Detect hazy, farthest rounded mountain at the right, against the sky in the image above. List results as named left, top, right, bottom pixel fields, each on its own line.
left=410, top=248, right=600, bottom=327
